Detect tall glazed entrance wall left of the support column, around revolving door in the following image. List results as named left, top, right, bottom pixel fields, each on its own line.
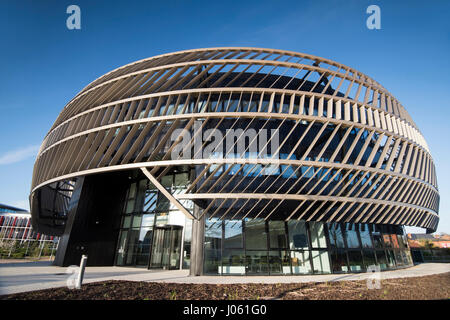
left=115, top=171, right=193, bottom=269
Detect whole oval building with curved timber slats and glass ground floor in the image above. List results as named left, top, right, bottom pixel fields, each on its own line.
left=30, top=48, right=439, bottom=275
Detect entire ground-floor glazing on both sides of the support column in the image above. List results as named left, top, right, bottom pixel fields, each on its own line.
left=110, top=170, right=412, bottom=275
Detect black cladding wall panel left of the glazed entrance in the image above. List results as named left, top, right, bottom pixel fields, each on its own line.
left=54, top=172, right=128, bottom=266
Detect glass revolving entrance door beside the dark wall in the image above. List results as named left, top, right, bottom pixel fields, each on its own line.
left=149, top=226, right=182, bottom=269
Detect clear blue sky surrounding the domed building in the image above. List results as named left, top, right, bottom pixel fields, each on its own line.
left=0, top=0, right=450, bottom=233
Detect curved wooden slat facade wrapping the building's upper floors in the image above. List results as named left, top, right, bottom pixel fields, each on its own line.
left=30, top=47, right=439, bottom=230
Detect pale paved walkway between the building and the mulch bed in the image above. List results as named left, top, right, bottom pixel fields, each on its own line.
left=0, top=260, right=450, bottom=295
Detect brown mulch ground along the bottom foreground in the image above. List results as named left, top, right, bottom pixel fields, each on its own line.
left=0, top=272, right=450, bottom=300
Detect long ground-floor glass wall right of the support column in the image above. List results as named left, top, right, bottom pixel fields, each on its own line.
left=204, top=219, right=412, bottom=275
